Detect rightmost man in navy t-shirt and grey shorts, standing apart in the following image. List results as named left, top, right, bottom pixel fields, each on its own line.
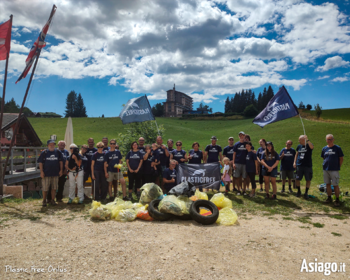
left=321, top=134, right=344, bottom=207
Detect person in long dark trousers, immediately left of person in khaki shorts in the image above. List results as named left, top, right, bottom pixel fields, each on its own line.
left=91, top=142, right=108, bottom=201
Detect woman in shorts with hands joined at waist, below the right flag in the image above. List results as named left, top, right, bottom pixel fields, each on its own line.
left=261, top=142, right=280, bottom=199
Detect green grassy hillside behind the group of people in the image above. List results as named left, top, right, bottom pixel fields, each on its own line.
left=29, top=116, right=350, bottom=186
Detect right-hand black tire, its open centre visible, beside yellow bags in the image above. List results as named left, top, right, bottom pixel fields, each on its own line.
left=190, top=199, right=219, bottom=225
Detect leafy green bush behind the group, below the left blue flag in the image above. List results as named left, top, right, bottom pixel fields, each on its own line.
left=117, top=121, right=164, bottom=156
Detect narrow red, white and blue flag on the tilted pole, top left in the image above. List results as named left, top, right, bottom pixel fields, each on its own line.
left=16, top=6, right=56, bottom=84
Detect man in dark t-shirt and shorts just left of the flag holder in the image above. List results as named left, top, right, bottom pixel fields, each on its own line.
left=280, top=140, right=296, bottom=193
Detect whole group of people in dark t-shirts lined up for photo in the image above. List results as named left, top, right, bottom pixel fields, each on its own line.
left=38, top=131, right=344, bottom=206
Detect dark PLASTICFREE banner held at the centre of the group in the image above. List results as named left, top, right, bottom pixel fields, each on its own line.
left=177, top=162, right=221, bottom=190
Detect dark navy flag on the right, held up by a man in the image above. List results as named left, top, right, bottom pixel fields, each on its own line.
left=253, top=86, right=299, bottom=127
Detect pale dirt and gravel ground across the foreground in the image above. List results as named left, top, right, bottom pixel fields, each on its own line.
left=0, top=214, right=350, bottom=279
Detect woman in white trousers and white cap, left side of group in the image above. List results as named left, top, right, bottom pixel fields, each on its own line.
left=65, top=144, right=84, bottom=204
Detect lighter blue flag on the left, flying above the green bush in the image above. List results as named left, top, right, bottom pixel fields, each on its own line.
left=119, top=95, right=154, bottom=124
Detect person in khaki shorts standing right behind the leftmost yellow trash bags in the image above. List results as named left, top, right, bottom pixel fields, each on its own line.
left=104, top=139, right=128, bottom=201
